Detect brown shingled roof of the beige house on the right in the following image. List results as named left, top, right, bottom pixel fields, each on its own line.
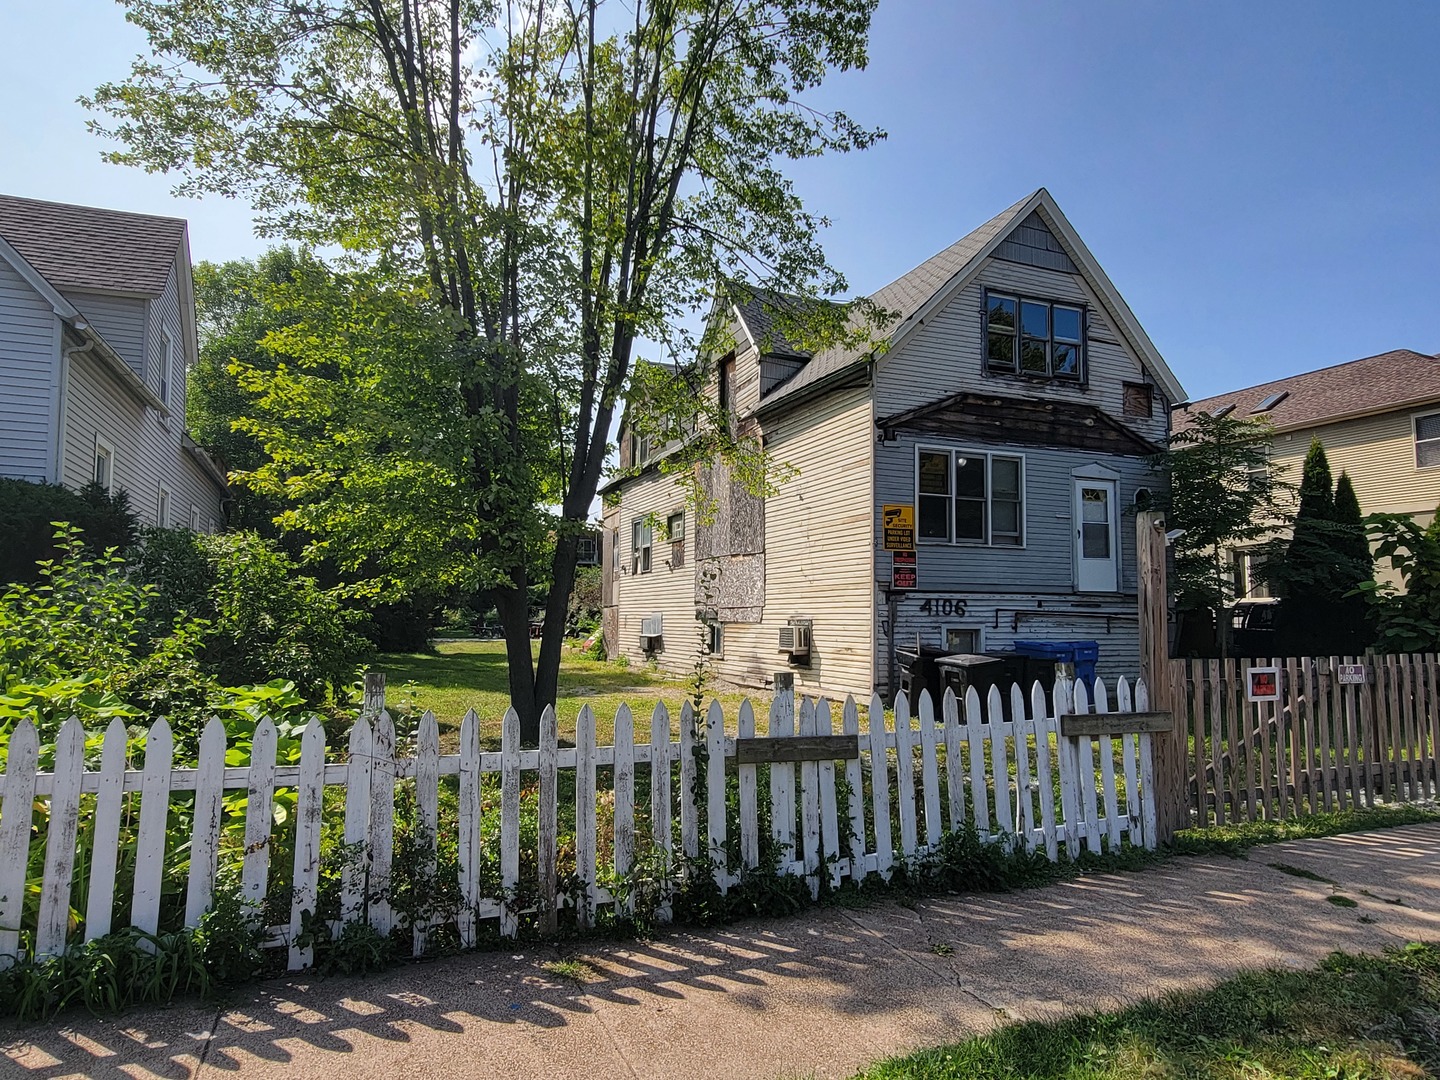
left=1174, top=348, right=1440, bottom=431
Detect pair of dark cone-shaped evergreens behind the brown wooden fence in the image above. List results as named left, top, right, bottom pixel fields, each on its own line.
left=1272, top=439, right=1374, bottom=655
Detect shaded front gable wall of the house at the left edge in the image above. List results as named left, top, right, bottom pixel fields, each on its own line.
left=0, top=261, right=59, bottom=481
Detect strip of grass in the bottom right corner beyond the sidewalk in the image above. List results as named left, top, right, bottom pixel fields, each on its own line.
left=857, top=945, right=1440, bottom=1080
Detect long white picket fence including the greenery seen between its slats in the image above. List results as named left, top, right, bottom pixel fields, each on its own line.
left=0, top=680, right=1156, bottom=969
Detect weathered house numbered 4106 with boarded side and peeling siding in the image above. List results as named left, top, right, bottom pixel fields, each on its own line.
left=605, top=189, right=1184, bottom=694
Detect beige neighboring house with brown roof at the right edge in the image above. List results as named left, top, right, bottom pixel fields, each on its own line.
left=1175, top=348, right=1440, bottom=598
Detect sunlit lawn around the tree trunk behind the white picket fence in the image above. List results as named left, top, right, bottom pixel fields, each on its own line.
left=373, top=641, right=770, bottom=752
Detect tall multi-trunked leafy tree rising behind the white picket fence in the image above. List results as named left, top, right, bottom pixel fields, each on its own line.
left=89, top=0, right=878, bottom=739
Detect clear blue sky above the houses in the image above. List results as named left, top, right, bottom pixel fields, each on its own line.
left=0, top=0, right=1440, bottom=397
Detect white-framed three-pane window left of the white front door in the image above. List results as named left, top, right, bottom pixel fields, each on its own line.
left=916, top=446, right=1025, bottom=547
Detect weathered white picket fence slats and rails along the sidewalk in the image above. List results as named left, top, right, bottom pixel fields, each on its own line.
left=0, top=680, right=1155, bottom=971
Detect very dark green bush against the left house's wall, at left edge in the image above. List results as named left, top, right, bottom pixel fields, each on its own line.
left=0, top=480, right=135, bottom=583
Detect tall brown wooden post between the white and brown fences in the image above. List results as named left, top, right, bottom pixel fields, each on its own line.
left=1135, top=510, right=1189, bottom=844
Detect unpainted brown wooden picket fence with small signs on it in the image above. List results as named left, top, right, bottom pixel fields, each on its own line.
left=1171, top=654, right=1440, bottom=827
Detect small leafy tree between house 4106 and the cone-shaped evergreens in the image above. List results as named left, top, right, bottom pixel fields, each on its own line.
left=1152, top=412, right=1290, bottom=654
